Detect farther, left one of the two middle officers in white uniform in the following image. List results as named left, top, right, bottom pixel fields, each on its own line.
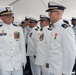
left=27, top=17, right=39, bottom=75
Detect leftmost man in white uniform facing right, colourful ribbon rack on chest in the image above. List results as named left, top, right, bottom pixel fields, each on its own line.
left=0, top=6, right=26, bottom=75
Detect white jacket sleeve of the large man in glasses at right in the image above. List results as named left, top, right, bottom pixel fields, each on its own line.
left=62, top=27, right=76, bottom=75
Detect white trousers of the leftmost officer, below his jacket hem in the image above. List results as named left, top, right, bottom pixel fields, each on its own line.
left=0, top=67, right=23, bottom=75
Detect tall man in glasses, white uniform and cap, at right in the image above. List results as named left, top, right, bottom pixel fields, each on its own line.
left=46, top=1, right=76, bottom=75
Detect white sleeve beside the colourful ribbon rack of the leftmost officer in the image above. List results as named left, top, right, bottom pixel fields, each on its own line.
left=20, top=28, right=26, bottom=64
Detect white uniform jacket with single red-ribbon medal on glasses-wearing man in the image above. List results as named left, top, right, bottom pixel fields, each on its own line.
left=49, top=20, right=76, bottom=75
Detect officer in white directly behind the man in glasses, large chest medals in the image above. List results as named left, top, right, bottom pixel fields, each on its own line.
left=35, top=15, right=51, bottom=75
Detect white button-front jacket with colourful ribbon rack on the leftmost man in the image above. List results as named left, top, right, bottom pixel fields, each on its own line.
left=0, top=23, right=26, bottom=71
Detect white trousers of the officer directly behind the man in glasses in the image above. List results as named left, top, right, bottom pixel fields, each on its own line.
left=36, top=65, right=50, bottom=75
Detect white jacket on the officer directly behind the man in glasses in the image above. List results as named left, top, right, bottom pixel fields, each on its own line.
left=35, top=26, right=51, bottom=66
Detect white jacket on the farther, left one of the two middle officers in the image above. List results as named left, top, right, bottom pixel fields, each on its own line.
left=27, top=26, right=39, bottom=56
